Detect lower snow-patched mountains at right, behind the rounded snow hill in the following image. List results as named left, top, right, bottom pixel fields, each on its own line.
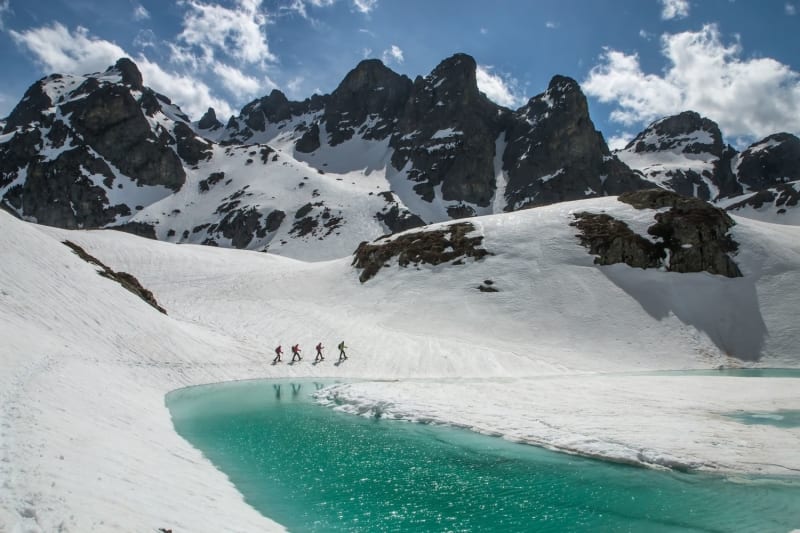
left=615, top=111, right=800, bottom=225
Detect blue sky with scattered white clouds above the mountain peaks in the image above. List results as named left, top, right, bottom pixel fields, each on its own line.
left=0, top=0, right=800, bottom=146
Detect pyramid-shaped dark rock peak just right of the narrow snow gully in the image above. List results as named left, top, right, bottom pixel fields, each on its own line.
left=503, top=76, right=649, bottom=211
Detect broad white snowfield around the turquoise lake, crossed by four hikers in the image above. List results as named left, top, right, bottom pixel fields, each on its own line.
left=0, top=194, right=800, bottom=531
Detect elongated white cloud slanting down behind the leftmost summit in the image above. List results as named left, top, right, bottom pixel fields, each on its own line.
left=9, top=23, right=233, bottom=117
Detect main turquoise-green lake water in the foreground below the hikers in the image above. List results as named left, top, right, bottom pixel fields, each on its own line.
left=167, top=381, right=800, bottom=533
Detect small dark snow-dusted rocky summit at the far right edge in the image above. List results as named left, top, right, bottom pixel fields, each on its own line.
left=738, top=133, right=800, bottom=191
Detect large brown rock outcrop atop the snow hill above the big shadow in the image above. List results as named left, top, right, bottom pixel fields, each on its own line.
left=573, top=189, right=742, bottom=278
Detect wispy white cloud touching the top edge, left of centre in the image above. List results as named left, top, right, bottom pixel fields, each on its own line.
left=178, top=0, right=276, bottom=64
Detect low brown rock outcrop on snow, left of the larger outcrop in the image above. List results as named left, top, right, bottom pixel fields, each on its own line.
left=353, top=222, right=490, bottom=283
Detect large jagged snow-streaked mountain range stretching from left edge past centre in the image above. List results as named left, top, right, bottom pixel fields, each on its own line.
left=0, top=54, right=647, bottom=259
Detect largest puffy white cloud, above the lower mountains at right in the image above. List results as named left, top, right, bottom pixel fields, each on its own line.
left=583, top=24, right=800, bottom=138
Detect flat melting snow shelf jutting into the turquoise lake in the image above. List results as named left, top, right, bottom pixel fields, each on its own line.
left=318, top=374, right=800, bottom=476
